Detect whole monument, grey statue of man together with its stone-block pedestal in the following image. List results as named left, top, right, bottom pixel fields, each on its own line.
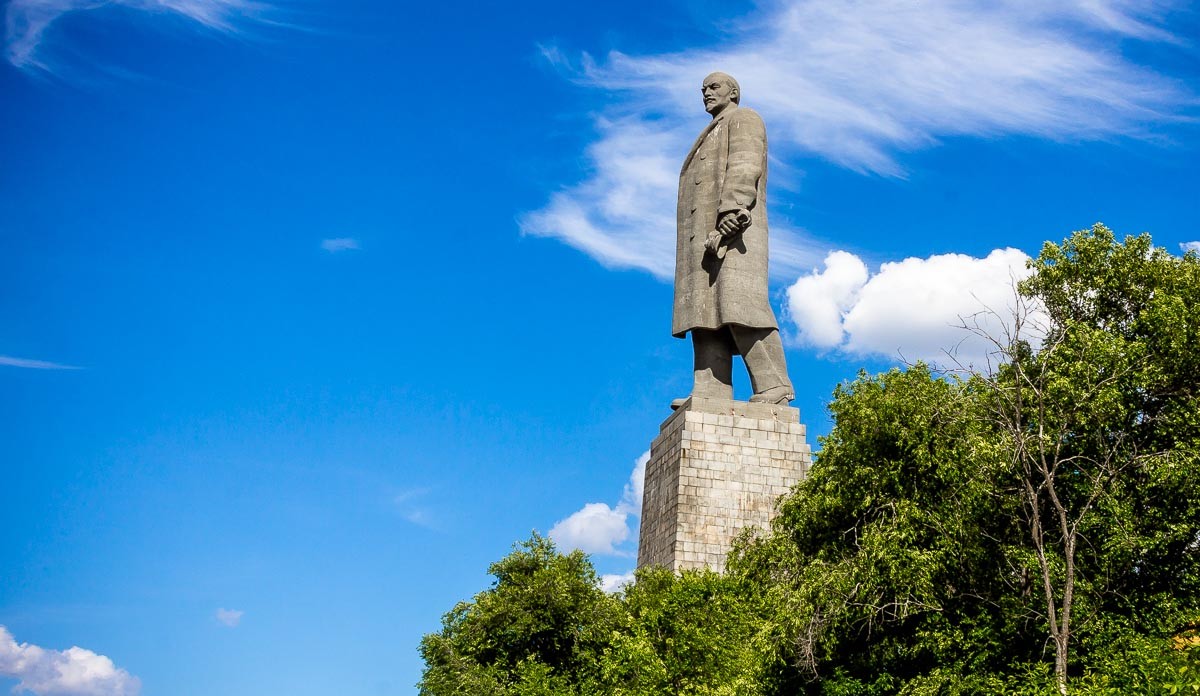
left=637, top=72, right=810, bottom=571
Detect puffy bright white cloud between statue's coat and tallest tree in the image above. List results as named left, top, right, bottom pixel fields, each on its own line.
left=787, top=248, right=1045, bottom=367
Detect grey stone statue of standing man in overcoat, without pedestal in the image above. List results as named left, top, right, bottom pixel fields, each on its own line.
left=671, top=72, right=796, bottom=408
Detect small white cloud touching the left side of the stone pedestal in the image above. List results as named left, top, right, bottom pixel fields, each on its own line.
left=550, top=451, right=650, bottom=556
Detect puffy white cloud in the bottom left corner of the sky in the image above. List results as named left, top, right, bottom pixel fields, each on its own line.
left=0, top=626, right=142, bottom=696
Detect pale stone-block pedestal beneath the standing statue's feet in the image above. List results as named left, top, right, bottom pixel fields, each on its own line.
left=637, top=397, right=811, bottom=571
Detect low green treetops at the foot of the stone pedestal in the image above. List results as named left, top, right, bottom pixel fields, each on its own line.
left=420, top=534, right=763, bottom=696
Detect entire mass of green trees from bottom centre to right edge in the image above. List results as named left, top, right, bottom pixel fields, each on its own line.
left=421, top=226, right=1200, bottom=696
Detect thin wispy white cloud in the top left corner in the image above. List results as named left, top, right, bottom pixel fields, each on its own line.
left=5, top=0, right=271, bottom=73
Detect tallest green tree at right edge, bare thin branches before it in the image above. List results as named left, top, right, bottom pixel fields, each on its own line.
left=977, top=224, right=1200, bottom=694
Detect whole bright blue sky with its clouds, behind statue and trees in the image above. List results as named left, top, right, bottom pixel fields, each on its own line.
left=0, top=0, right=1200, bottom=696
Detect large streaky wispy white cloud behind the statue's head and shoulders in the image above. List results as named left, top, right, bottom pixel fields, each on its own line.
left=521, top=0, right=1195, bottom=281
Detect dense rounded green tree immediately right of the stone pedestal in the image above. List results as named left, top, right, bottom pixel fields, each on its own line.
left=731, top=365, right=1025, bottom=694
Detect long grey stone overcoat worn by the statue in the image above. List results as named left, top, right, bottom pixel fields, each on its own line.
left=671, top=106, right=779, bottom=338
